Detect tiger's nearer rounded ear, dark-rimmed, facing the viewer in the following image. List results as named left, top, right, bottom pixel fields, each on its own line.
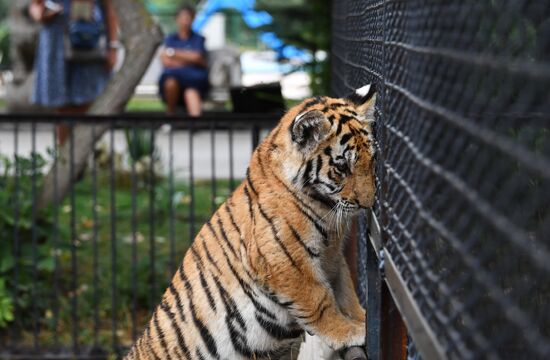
left=290, top=110, right=330, bottom=151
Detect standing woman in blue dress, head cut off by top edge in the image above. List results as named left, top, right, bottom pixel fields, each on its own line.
left=29, top=0, right=119, bottom=144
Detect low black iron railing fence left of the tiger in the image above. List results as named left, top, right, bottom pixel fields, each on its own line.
left=0, top=114, right=278, bottom=359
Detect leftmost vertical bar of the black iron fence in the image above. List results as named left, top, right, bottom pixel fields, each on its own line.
left=10, top=123, right=21, bottom=347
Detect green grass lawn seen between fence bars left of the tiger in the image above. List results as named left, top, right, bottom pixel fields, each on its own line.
left=14, top=167, right=239, bottom=348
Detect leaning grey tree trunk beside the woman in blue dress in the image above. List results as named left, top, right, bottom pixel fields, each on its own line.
left=38, top=0, right=163, bottom=209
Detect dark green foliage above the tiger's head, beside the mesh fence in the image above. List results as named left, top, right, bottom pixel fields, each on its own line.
left=256, top=0, right=331, bottom=95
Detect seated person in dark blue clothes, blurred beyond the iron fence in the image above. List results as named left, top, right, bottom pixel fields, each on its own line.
left=159, top=6, right=209, bottom=116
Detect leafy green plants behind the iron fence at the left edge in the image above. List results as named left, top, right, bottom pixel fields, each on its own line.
left=0, top=150, right=53, bottom=334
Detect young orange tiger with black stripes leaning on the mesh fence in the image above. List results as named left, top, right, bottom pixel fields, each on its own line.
left=125, top=86, right=376, bottom=360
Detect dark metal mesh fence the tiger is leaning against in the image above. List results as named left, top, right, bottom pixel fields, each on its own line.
left=333, top=0, right=550, bottom=359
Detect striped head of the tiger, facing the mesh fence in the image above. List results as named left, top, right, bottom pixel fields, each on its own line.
left=277, top=85, right=376, bottom=213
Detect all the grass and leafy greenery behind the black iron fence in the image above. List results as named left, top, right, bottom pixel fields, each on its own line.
left=0, top=148, right=235, bottom=346
